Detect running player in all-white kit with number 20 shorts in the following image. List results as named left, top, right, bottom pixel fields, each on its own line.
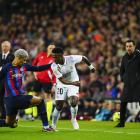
left=51, top=47, right=95, bottom=130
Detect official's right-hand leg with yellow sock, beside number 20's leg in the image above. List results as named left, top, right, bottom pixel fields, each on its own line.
left=45, top=93, right=53, bottom=121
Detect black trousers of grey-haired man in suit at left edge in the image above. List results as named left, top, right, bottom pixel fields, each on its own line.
left=0, top=80, right=6, bottom=119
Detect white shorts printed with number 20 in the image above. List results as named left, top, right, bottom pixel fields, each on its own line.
left=55, top=86, right=79, bottom=100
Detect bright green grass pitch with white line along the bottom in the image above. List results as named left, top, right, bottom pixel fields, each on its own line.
left=0, top=120, right=140, bottom=140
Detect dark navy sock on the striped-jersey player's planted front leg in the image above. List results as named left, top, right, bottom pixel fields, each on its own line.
left=37, top=99, right=49, bottom=127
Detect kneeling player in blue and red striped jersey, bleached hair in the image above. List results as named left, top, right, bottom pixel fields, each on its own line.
left=0, top=49, right=55, bottom=132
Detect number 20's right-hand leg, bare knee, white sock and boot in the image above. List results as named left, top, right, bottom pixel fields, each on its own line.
left=70, top=96, right=79, bottom=130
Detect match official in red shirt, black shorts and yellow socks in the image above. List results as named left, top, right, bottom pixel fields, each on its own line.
left=32, top=43, right=56, bottom=121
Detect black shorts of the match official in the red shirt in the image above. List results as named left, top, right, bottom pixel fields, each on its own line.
left=33, top=80, right=52, bottom=93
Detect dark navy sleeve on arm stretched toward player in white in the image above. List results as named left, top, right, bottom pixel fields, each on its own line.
left=25, top=63, right=52, bottom=71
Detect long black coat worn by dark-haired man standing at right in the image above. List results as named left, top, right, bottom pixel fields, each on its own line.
left=120, top=50, right=140, bottom=102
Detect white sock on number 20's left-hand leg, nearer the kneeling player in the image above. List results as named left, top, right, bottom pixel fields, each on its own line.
left=52, top=108, right=61, bottom=129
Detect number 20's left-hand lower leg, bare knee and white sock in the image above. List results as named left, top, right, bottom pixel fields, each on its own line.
left=52, top=100, right=64, bottom=129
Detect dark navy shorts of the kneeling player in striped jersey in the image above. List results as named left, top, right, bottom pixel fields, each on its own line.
left=4, top=95, right=33, bottom=116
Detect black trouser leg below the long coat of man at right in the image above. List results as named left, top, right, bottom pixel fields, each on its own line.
left=120, top=102, right=127, bottom=124
